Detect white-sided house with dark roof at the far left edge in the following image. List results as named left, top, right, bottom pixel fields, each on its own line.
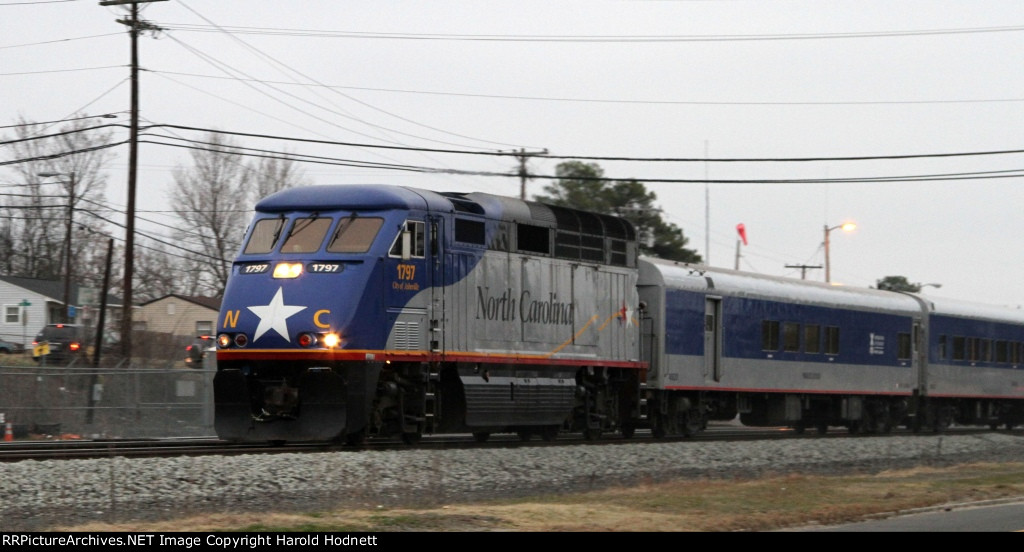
left=0, top=275, right=122, bottom=345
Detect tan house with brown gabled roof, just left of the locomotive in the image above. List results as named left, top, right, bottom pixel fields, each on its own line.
left=132, top=293, right=220, bottom=340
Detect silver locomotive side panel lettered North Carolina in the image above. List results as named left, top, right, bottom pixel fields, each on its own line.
left=445, top=242, right=639, bottom=365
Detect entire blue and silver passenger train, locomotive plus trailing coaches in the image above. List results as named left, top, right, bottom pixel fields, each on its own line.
left=214, top=185, right=1024, bottom=443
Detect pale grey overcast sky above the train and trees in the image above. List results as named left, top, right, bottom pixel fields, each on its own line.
left=0, top=0, right=1024, bottom=306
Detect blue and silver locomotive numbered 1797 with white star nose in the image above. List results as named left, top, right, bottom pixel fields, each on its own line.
left=214, top=185, right=644, bottom=442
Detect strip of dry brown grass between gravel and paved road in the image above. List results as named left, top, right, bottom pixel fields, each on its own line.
left=54, top=463, right=1024, bottom=533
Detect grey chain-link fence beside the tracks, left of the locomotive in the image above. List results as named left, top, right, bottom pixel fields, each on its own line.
left=0, top=354, right=215, bottom=439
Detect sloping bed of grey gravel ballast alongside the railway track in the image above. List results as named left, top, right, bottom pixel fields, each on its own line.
left=0, top=432, right=1024, bottom=530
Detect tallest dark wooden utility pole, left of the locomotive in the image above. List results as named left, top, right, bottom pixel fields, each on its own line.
left=99, top=0, right=167, bottom=360
